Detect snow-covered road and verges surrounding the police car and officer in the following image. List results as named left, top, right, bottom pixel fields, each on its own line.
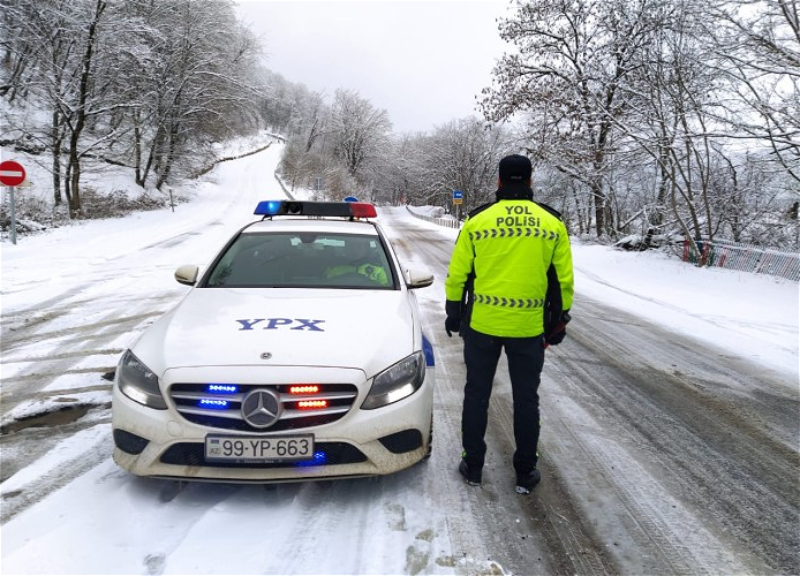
left=0, top=145, right=800, bottom=575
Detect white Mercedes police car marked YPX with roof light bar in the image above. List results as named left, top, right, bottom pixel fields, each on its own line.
left=112, top=200, right=434, bottom=482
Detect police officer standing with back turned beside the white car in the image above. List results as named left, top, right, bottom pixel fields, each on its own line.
left=445, top=154, right=573, bottom=494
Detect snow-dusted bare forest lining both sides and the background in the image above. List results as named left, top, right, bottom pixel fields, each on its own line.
left=0, top=0, right=800, bottom=252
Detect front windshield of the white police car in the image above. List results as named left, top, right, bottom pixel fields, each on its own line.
left=205, top=232, right=396, bottom=289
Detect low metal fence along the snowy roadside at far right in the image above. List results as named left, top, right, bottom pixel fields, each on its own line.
left=683, top=240, right=800, bottom=281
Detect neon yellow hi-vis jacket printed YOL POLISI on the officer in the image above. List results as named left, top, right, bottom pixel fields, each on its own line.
left=445, top=200, right=574, bottom=338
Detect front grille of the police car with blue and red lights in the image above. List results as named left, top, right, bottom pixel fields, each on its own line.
left=169, top=383, right=358, bottom=432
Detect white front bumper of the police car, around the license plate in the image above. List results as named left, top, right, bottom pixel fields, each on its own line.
left=112, top=366, right=435, bottom=482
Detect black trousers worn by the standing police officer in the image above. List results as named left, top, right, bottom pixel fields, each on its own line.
left=461, top=328, right=544, bottom=474
